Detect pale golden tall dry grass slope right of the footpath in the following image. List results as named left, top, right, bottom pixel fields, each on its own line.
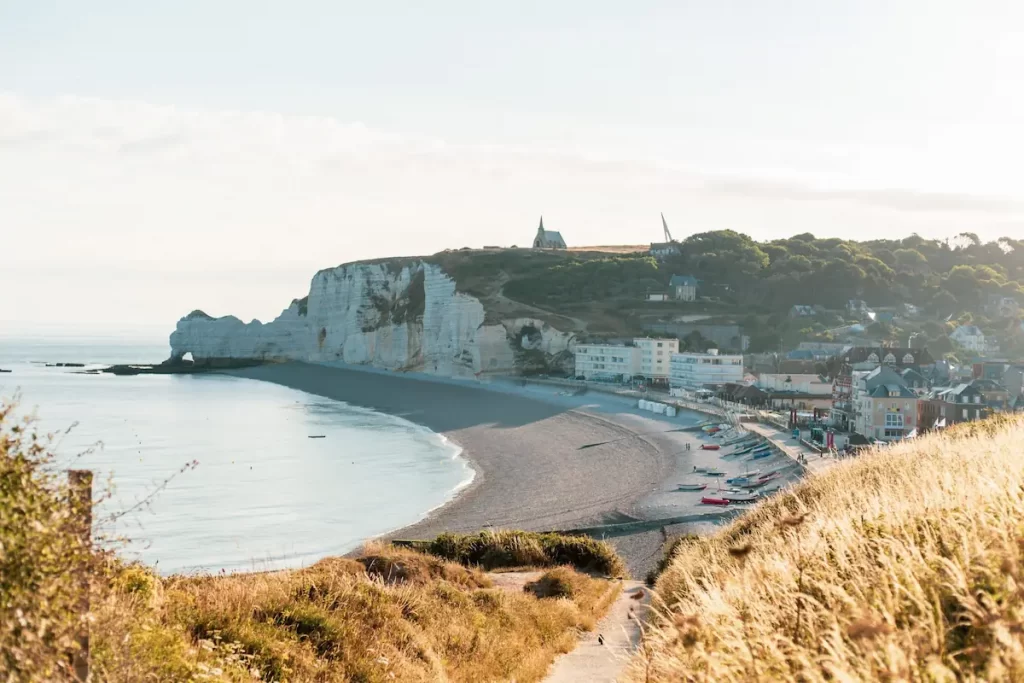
left=631, top=418, right=1024, bottom=682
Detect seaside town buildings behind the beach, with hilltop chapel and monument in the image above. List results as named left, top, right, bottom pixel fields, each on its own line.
left=534, top=215, right=1024, bottom=453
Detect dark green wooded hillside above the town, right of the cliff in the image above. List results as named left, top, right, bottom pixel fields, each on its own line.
left=417, top=235, right=1024, bottom=355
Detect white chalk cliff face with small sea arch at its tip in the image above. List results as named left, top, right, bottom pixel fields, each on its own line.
left=170, top=261, right=574, bottom=377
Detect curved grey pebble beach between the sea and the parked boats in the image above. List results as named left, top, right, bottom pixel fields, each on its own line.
left=229, top=362, right=770, bottom=577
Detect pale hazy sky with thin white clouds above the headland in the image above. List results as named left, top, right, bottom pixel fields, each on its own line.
left=0, top=0, right=1024, bottom=335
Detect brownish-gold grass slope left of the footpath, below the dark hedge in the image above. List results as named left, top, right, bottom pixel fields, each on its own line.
left=86, top=545, right=617, bottom=682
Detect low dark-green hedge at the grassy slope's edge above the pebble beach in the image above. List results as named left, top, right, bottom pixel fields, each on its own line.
left=422, top=530, right=627, bottom=578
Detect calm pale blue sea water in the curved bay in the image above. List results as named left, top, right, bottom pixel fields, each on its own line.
left=0, top=337, right=472, bottom=573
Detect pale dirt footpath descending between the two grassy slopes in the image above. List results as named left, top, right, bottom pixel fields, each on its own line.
left=544, top=581, right=650, bottom=683
